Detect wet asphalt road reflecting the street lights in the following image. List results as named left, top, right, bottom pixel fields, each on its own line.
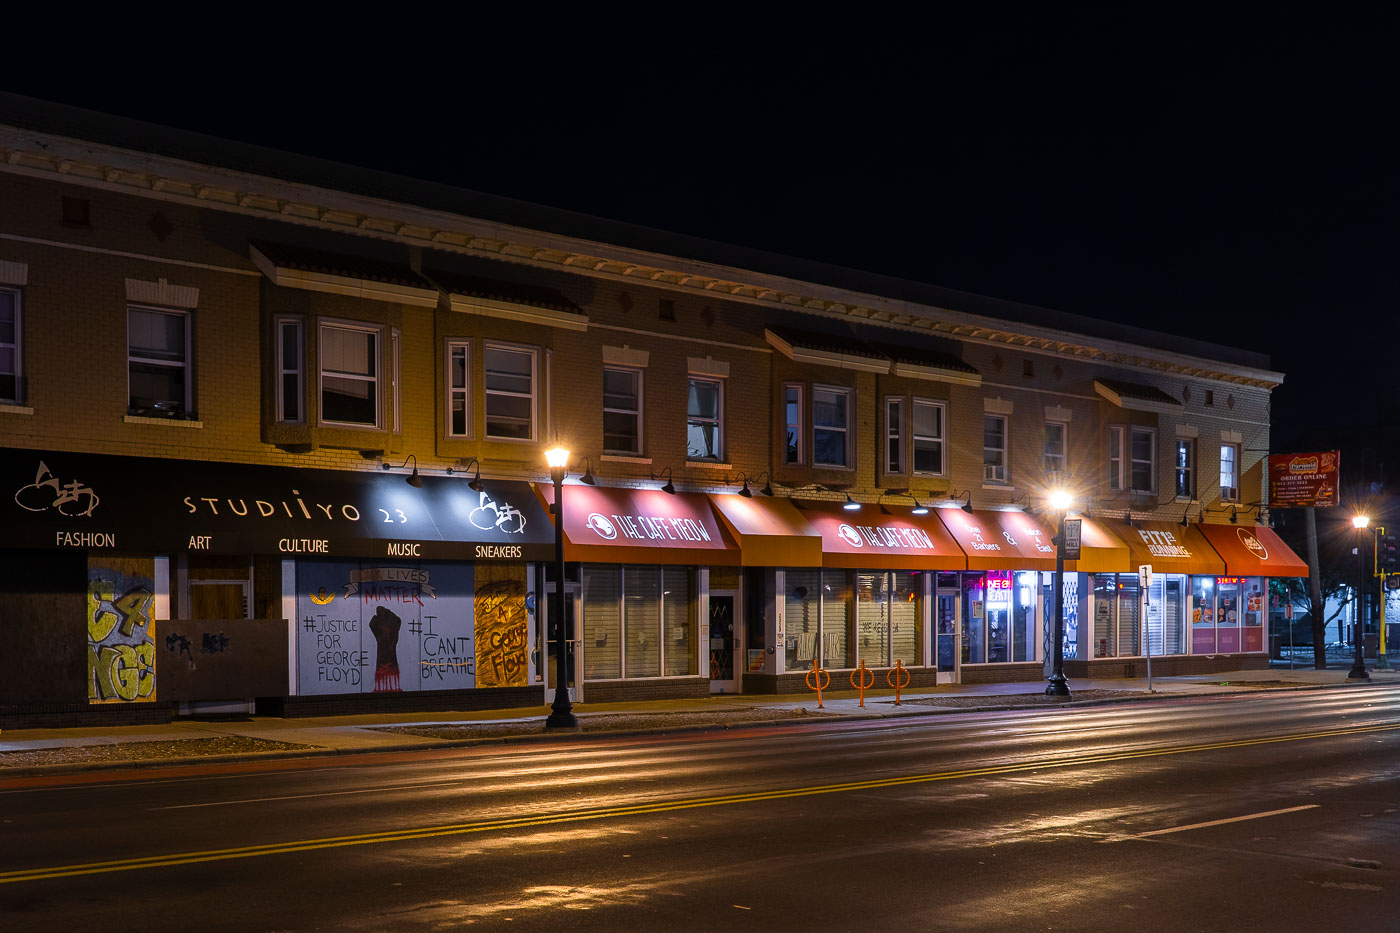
left=0, top=686, right=1400, bottom=933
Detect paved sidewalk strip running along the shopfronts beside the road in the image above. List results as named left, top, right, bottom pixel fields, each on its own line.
left=0, top=667, right=1400, bottom=776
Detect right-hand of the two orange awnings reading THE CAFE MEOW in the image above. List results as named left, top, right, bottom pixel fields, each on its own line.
left=795, top=500, right=967, bottom=570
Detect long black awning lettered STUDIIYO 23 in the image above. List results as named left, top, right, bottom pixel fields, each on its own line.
left=0, top=450, right=554, bottom=560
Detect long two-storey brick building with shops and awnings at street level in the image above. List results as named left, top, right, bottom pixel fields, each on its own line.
left=0, top=92, right=1305, bottom=721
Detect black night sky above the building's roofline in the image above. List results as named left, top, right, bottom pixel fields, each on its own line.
left=10, top=3, right=1400, bottom=450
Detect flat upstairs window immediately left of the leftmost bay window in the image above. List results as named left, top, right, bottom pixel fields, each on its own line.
left=126, top=305, right=193, bottom=417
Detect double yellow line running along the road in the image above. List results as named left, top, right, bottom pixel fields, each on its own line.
left=0, top=714, right=1400, bottom=884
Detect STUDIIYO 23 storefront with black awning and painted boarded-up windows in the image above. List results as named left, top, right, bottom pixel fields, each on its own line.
left=3, top=450, right=553, bottom=712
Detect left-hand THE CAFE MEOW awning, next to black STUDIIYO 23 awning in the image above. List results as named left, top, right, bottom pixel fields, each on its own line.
left=535, top=483, right=739, bottom=566
